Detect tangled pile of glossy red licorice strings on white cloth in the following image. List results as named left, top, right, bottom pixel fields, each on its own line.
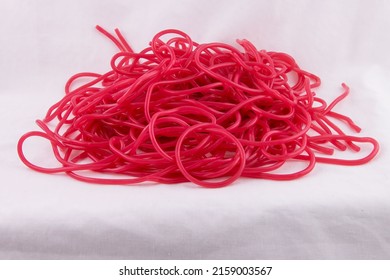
left=18, top=26, right=379, bottom=187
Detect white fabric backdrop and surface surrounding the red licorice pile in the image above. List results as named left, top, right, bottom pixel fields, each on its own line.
left=0, top=0, right=390, bottom=259
